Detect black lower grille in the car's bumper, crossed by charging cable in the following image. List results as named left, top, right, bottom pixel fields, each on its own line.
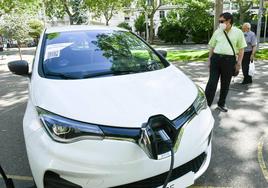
left=114, top=152, right=207, bottom=188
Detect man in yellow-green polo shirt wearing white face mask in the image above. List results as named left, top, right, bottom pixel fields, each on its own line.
left=205, top=12, right=247, bottom=112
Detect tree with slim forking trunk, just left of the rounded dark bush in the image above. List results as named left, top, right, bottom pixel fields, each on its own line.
left=137, top=0, right=164, bottom=43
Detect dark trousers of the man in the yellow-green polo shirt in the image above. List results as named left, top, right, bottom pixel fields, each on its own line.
left=205, top=54, right=236, bottom=106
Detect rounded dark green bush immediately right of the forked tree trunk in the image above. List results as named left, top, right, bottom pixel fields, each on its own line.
left=157, top=12, right=187, bottom=44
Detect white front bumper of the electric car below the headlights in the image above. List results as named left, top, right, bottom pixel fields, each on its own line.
left=23, top=102, right=214, bottom=188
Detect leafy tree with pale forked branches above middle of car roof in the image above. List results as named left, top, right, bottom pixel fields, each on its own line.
left=86, top=0, right=131, bottom=25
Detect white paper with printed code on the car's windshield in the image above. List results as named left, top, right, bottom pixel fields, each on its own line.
left=44, top=42, right=73, bottom=61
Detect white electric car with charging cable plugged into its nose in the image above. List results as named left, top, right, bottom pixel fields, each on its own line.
left=9, top=26, right=214, bottom=188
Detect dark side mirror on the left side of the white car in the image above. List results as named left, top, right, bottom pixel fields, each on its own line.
left=8, top=60, right=29, bottom=76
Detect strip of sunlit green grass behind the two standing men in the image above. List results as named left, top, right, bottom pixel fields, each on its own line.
left=167, top=49, right=268, bottom=62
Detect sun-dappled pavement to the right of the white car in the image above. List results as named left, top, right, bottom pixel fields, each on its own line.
left=176, top=61, right=268, bottom=188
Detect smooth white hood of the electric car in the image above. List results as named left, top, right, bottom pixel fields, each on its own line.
left=31, top=65, right=197, bottom=128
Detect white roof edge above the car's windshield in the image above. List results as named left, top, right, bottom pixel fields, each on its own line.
left=45, top=25, right=128, bottom=33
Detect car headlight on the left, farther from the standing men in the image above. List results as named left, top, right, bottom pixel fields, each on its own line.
left=37, top=108, right=104, bottom=143
